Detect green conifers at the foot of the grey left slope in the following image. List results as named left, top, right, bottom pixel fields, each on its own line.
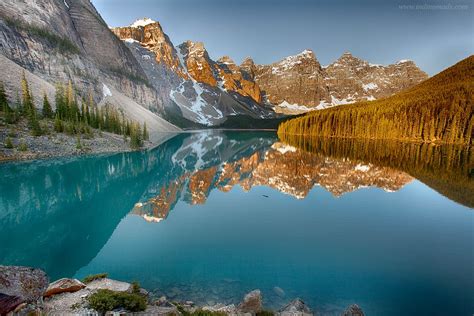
left=0, top=73, right=149, bottom=148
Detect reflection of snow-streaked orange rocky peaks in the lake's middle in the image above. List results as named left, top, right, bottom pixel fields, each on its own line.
left=132, top=134, right=412, bottom=222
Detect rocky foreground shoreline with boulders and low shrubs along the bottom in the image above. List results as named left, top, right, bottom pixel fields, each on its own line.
left=0, top=266, right=364, bottom=316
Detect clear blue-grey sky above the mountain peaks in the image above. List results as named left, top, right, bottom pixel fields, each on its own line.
left=92, top=0, right=474, bottom=75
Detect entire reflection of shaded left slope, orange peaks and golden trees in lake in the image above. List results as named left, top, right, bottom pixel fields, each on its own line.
left=0, top=131, right=474, bottom=278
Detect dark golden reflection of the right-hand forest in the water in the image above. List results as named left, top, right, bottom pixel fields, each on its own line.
left=281, top=135, right=474, bottom=207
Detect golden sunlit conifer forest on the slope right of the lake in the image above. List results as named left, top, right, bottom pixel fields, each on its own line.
left=278, top=56, right=474, bottom=144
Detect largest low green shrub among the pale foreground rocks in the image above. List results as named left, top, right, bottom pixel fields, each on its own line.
left=87, top=289, right=147, bottom=313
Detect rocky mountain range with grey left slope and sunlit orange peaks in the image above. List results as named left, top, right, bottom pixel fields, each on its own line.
left=0, top=0, right=428, bottom=132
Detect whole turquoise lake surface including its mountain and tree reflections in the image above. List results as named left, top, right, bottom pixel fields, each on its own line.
left=0, top=131, right=474, bottom=315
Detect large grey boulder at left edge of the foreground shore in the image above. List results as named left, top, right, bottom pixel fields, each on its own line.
left=0, top=266, right=49, bottom=302
